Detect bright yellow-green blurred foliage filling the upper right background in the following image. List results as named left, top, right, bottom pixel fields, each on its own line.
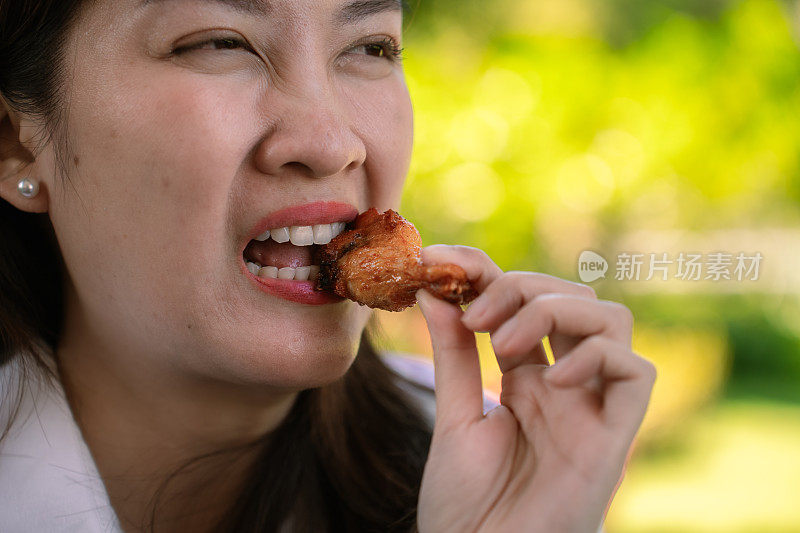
left=404, top=0, right=800, bottom=275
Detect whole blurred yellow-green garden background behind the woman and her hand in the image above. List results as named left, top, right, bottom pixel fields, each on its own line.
left=382, top=0, right=800, bottom=532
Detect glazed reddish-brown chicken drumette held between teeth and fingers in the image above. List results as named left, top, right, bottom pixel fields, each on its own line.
left=316, top=208, right=477, bottom=311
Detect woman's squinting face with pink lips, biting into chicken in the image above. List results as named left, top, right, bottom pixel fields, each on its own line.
left=45, top=0, right=412, bottom=388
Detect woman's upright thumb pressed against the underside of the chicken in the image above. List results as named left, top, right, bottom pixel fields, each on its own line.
left=416, top=289, right=483, bottom=428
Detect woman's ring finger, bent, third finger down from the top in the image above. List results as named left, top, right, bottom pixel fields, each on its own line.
left=491, top=293, right=632, bottom=370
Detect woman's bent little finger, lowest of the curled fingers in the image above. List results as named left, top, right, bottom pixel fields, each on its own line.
left=544, top=336, right=656, bottom=439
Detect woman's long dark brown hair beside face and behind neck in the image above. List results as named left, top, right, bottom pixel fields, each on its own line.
left=0, top=0, right=431, bottom=532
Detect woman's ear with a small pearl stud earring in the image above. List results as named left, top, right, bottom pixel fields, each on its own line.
left=0, top=95, right=48, bottom=213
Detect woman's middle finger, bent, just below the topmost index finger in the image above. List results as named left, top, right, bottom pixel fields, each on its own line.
left=462, top=272, right=597, bottom=331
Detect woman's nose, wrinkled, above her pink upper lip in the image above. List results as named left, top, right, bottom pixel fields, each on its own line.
left=255, top=95, right=367, bottom=178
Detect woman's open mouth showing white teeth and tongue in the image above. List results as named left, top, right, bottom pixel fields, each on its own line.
left=242, top=222, right=345, bottom=281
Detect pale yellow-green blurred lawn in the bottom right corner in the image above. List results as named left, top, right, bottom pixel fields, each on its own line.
left=606, top=402, right=800, bottom=533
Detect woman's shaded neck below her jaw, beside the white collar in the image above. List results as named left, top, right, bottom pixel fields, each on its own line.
left=57, top=308, right=297, bottom=531
